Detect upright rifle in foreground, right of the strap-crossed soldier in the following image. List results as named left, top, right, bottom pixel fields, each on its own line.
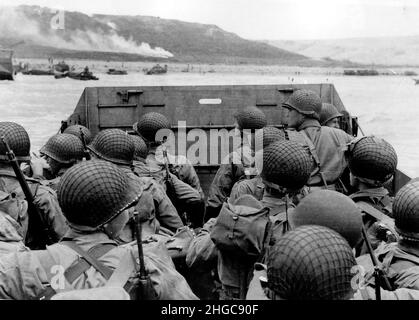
left=134, top=211, right=157, bottom=300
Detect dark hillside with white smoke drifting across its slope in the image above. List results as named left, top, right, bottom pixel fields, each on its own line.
left=0, top=6, right=316, bottom=66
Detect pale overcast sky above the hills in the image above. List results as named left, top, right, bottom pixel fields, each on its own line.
left=0, top=0, right=419, bottom=40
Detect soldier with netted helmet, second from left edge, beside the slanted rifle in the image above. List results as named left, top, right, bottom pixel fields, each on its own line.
left=34, top=133, right=84, bottom=191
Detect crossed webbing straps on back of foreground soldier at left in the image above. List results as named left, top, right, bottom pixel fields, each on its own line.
left=60, top=241, right=116, bottom=283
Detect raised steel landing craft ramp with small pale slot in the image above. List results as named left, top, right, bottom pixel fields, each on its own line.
left=66, top=84, right=410, bottom=193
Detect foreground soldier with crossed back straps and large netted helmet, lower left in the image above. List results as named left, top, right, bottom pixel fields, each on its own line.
left=0, top=160, right=196, bottom=300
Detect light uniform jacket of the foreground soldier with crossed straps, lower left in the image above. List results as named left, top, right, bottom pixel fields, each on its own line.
left=0, top=231, right=197, bottom=300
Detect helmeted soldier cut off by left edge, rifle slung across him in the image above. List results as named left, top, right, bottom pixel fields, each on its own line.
left=0, top=122, right=67, bottom=249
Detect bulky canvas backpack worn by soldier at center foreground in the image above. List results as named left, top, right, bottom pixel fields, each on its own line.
left=210, top=195, right=272, bottom=257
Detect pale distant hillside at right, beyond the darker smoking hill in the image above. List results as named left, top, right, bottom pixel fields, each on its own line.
left=266, top=36, right=419, bottom=66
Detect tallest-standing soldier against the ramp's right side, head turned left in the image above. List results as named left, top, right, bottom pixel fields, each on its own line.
left=282, top=90, right=353, bottom=189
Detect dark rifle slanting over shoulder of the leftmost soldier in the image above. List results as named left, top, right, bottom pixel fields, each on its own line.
left=1, top=136, right=54, bottom=250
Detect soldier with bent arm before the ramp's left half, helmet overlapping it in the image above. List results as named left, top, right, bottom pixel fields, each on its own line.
left=134, top=112, right=205, bottom=228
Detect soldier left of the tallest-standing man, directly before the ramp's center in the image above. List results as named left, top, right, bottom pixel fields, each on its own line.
left=205, top=107, right=267, bottom=221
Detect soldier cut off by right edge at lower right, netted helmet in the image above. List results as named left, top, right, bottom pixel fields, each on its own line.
left=358, top=181, right=419, bottom=290
